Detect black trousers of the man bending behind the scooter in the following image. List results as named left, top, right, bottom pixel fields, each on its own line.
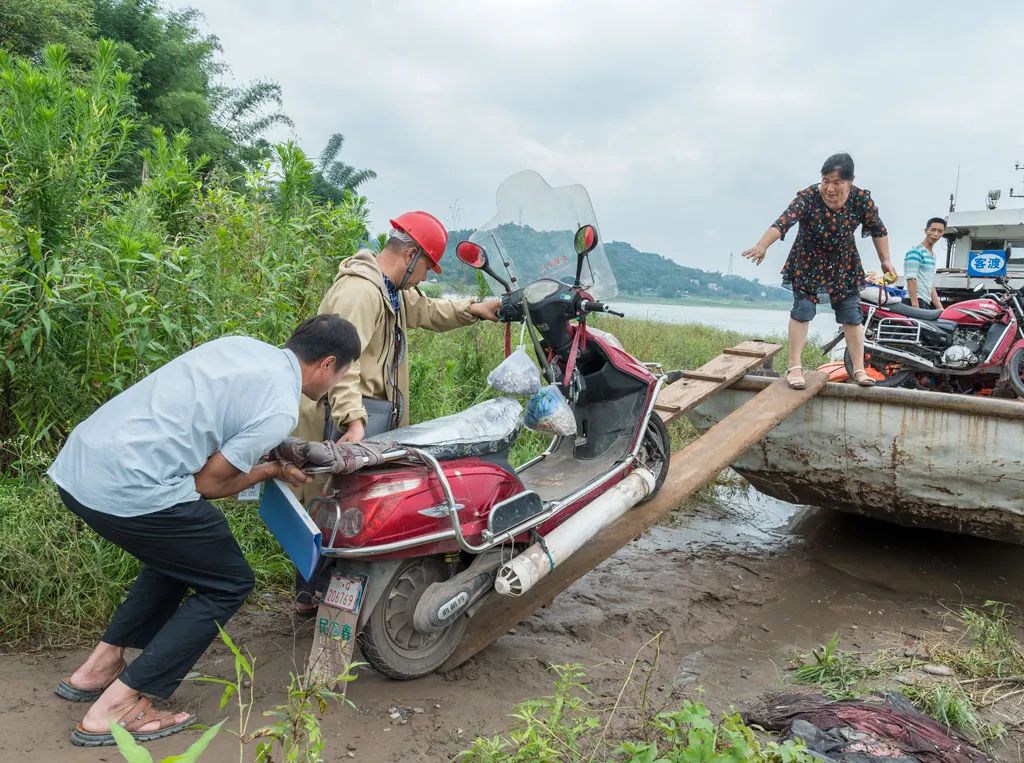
left=60, top=490, right=255, bottom=698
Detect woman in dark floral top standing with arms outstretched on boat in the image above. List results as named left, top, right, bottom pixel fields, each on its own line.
left=743, top=154, right=896, bottom=389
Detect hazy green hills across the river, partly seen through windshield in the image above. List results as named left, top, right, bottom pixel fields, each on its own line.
left=430, top=225, right=793, bottom=302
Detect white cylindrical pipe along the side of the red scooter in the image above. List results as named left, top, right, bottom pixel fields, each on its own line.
left=495, top=467, right=654, bottom=596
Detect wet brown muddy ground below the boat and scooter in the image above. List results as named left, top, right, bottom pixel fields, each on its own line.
left=0, top=481, right=1024, bottom=763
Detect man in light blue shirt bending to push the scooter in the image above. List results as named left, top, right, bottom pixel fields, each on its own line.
left=48, top=315, right=360, bottom=747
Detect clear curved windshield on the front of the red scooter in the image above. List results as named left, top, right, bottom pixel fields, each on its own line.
left=469, top=170, right=618, bottom=299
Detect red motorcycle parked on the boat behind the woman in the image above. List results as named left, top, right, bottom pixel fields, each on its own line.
left=844, top=278, right=1024, bottom=397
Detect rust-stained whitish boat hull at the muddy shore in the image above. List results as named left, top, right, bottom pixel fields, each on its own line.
left=687, top=376, right=1024, bottom=544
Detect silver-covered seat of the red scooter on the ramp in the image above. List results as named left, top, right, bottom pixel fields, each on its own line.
left=373, top=397, right=522, bottom=461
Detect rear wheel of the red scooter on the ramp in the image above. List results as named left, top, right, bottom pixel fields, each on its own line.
left=359, top=556, right=467, bottom=681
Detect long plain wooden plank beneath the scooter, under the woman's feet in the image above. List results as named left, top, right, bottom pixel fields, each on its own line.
left=440, top=370, right=826, bottom=671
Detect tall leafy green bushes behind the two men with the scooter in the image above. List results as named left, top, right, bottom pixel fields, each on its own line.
left=0, top=42, right=367, bottom=474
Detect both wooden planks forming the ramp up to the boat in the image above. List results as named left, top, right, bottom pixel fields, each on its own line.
left=440, top=342, right=826, bottom=672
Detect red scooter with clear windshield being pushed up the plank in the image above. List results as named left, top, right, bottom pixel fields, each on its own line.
left=313, top=172, right=671, bottom=679
